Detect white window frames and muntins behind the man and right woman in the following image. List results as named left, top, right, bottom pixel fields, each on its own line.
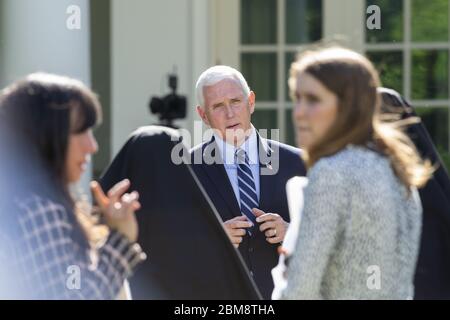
left=211, top=0, right=450, bottom=151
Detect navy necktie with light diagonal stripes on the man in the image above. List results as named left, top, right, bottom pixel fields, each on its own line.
left=235, top=149, right=259, bottom=225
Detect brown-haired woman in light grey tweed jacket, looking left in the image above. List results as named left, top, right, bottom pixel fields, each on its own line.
left=281, top=48, right=432, bottom=299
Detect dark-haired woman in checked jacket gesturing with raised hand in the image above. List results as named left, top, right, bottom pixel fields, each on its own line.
left=0, top=73, right=145, bottom=299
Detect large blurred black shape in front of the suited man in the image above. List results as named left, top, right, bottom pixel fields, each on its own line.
left=101, top=127, right=260, bottom=300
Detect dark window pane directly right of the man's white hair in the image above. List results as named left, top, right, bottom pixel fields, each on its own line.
left=241, top=53, right=277, bottom=101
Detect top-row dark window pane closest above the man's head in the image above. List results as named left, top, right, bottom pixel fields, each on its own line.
left=241, top=0, right=277, bottom=44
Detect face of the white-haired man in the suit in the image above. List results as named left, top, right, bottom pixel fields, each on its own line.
left=197, top=79, right=255, bottom=146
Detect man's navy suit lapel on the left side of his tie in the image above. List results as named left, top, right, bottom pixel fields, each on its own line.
left=201, top=137, right=241, bottom=220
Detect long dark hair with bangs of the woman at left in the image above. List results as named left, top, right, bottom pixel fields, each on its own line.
left=0, top=73, right=105, bottom=245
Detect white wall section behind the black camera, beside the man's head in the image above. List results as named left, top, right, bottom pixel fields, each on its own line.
left=111, top=0, right=211, bottom=154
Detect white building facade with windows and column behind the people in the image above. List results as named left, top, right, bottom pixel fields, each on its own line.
left=0, top=0, right=450, bottom=175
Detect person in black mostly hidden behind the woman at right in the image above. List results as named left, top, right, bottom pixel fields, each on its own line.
left=380, top=88, right=450, bottom=299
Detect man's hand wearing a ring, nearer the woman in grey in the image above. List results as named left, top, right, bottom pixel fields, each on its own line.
left=252, top=208, right=289, bottom=243
